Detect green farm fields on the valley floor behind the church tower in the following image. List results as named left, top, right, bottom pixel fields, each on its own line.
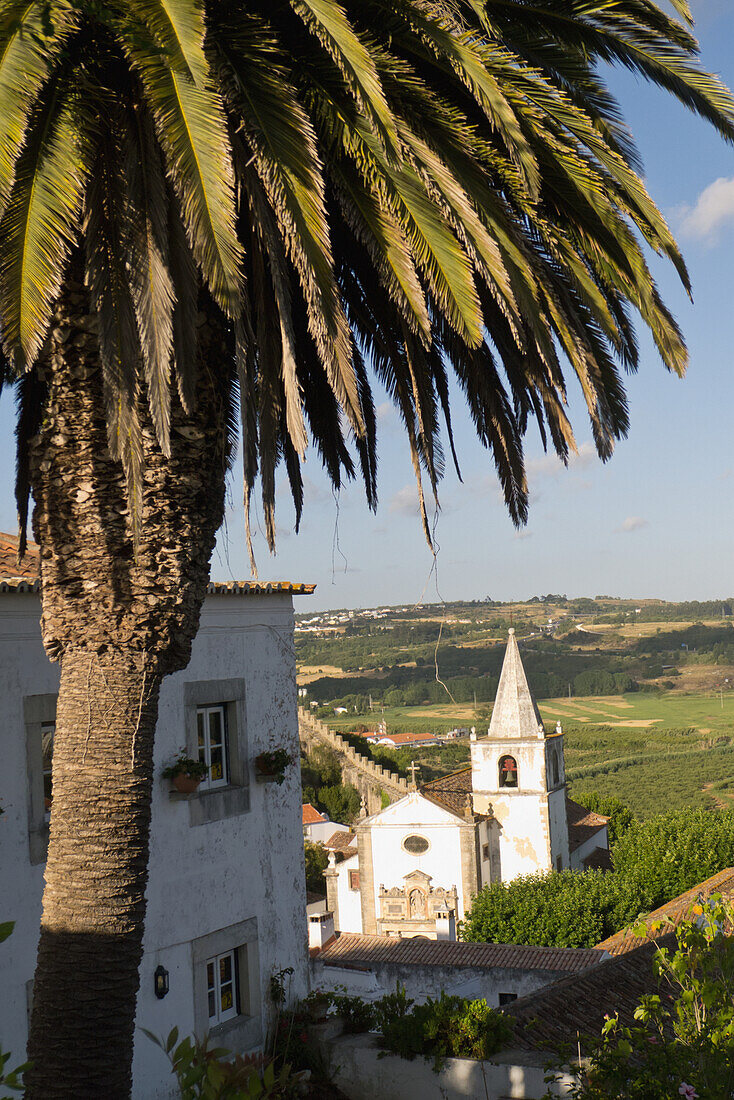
left=330, top=692, right=734, bottom=817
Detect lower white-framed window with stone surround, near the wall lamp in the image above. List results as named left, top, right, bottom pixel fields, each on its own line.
left=192, top=917, right=263, bottom=1051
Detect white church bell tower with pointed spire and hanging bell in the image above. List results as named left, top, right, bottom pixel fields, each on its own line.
left=471, top=628, right=569, bottom=882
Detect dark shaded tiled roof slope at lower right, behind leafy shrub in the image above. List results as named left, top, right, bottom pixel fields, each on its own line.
left=503, top=935, right=673, bottom=1054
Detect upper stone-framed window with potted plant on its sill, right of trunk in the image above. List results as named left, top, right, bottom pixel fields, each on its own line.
left=183, top=680, right=250, bottom=826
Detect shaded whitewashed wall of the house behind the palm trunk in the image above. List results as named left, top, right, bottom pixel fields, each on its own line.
left=0, top=595, right=307, bottom=1100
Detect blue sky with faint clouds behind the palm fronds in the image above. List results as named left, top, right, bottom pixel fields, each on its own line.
left=0, top=0, right=734, bottom=611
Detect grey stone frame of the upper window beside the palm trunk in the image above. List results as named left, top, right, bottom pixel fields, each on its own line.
left=182, top=679, right=250, bottom=827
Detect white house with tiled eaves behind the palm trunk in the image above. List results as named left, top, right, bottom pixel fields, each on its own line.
left=0, top=537, right=313, bottom=1100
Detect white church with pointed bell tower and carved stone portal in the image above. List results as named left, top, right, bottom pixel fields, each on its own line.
left=325, top=629, right=611, bottom=938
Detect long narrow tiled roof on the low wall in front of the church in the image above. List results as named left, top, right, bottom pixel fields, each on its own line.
left=318, top=932, right=604, bottom=974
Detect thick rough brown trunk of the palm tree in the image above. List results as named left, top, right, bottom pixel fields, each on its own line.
left=26, top=272, right=231, bottom=1100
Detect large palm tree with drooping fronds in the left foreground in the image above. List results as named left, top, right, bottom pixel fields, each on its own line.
left=0, top=0, right=734, bottom=1100
